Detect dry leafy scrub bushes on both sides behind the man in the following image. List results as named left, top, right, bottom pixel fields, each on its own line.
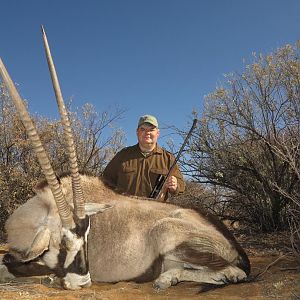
left=0, top=43, right=300, bottom=251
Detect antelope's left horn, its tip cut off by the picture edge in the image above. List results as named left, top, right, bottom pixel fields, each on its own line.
left=0, top=58, right=74, bottom=228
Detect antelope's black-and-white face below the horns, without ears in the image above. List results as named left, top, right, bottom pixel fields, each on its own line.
left=57, top=215, right=91, bottom=290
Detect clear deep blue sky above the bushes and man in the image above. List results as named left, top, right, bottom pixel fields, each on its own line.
left=0, top=0, right=300, bottom=145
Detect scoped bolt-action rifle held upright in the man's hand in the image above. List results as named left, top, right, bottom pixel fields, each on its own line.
left=149, top=119, right=197, bottom=201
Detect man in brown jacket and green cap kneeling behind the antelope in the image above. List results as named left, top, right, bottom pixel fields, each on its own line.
left=103, top=115, right=185, bottom=200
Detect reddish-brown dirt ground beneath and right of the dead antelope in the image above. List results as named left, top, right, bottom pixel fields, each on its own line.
left=0, top=234, right=300, bottom=300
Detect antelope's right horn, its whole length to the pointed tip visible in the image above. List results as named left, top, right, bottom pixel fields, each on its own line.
left=42, top=26, right=85, bottom=219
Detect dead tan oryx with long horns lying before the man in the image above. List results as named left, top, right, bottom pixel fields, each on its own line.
left=0, top=28, right=250, bottom=289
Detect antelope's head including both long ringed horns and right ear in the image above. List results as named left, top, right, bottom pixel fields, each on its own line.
left=0, top=27, right=111, bottom=289
